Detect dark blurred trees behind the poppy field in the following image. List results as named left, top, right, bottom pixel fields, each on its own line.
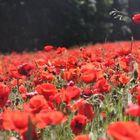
left=0, top=0, right=140, bottom=52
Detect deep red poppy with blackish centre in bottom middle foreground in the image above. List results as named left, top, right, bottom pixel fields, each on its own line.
left=70, top=114, right=87, bottom=135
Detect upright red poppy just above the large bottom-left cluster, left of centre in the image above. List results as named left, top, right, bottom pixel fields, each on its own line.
left=36, top=83, right=57, bottom=99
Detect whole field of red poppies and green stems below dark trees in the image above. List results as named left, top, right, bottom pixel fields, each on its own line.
left=0, top=41, right=140, bottom=140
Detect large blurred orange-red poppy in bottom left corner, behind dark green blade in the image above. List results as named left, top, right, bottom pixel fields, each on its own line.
left=3, top=110, right=38, bottom=140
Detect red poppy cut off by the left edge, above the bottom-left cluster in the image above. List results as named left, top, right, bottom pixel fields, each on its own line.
left=0, top=83, right=10, bottom=107
